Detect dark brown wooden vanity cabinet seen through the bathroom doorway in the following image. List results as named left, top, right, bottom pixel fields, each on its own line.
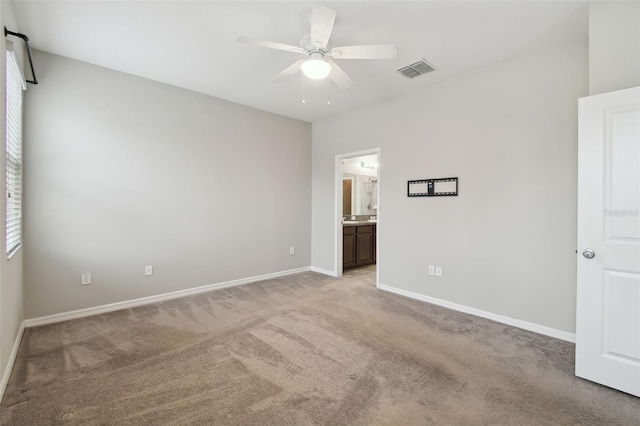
left=342, top=224, right=376, bottom=270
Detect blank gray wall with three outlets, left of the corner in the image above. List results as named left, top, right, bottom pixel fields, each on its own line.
left=24, top=52, right=311, bottom=318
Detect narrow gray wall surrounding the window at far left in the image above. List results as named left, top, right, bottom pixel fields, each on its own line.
left=0, top=1, right=24, bottom=386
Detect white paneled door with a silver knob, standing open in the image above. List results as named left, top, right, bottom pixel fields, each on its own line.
left=576, top=87, right=640, bottom=396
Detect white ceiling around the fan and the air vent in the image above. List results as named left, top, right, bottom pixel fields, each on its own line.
left=13, top=0, right=587, bottom=122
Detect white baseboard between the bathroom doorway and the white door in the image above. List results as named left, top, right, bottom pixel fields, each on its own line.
left=378, top=284, right=576, bottom=343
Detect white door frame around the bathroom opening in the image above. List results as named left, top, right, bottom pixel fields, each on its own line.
left=334, top=148, right=382, bottom=288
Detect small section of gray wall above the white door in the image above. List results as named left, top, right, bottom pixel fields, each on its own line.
left=589, top=1, right=640, bottom=95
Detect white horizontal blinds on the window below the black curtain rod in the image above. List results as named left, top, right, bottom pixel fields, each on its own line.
left=5, top=42, right=26, bottom=256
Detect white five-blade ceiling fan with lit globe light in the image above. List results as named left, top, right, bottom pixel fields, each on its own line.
left=238, top=6, right=396, bottom=89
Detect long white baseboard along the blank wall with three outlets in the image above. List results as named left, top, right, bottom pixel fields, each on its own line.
left=24, top=266, right=311, bottom=327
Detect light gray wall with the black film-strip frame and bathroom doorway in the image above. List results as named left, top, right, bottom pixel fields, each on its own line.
left=312, top=35, right=588, bottom=332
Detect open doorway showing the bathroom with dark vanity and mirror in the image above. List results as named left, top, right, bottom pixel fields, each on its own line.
left=335, top=148, right=380, bottom=287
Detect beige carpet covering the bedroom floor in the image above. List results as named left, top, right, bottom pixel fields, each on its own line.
left=0, top=268, right=640, bottom=426
